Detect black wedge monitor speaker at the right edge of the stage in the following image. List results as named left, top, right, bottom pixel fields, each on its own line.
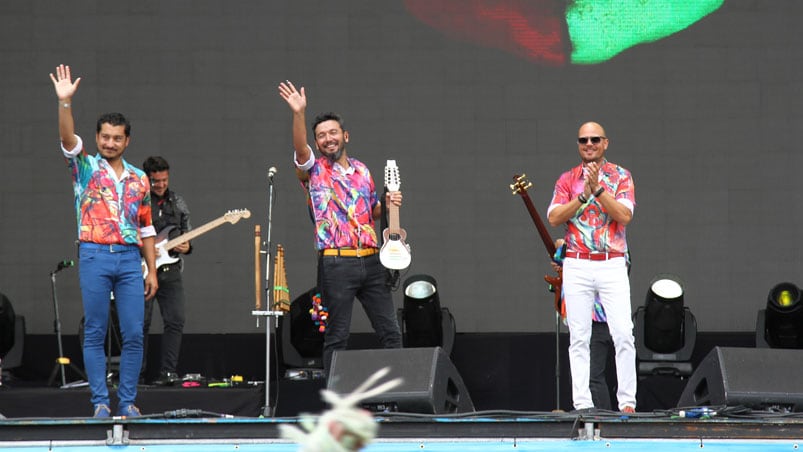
left=678, top=347, right=803, bottom=411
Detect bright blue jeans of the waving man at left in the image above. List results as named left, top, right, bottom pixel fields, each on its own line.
left=78, top=242, right=145, bottom=407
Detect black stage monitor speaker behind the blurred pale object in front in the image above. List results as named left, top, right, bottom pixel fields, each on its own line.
left=327, top=347, right=474, bottom=414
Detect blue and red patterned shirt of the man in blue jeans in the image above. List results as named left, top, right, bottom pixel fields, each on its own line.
left=62, top=136, right=156, bottom=246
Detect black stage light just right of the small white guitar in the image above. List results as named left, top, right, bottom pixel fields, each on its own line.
left=399, top=275, right=455, bottom=355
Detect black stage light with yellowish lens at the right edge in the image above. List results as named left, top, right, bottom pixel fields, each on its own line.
left=756, top=282, right=803, bottom=349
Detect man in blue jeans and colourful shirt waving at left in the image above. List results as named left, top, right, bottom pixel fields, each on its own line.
left=50, top=65, right=158, bottom=417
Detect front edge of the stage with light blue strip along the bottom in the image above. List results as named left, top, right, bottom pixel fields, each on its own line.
left=0, top=412, right=803, bottom=452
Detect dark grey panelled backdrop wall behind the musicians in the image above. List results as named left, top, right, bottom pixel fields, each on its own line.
left=0, top=0, right=803, bottom=333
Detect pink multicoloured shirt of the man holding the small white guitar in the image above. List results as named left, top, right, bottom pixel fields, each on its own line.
left=299, top=157, right=379, bottom=250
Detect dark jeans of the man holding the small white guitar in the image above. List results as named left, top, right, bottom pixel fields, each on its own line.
left=318, top=254, right=402, bottom=375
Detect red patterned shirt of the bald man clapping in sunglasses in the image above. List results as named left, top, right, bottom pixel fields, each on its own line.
left=548, top=160, right=636, bottom=253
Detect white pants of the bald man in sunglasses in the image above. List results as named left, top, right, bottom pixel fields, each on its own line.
left=563, top=257, right=637, bottom=410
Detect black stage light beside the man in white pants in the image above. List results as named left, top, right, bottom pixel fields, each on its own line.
left=633, top=274, right=697, bottom=376
